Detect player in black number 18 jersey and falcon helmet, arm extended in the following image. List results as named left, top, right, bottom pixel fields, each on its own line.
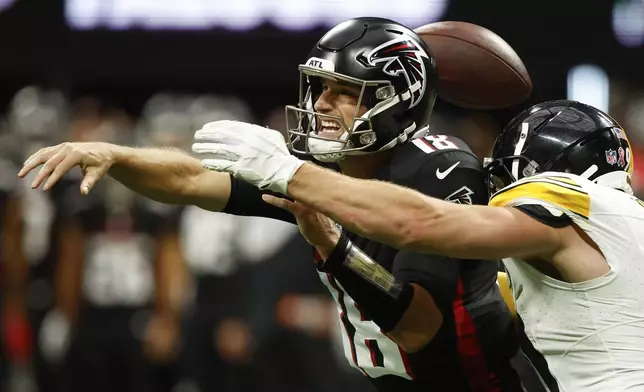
left=19, top=18, right=536, bottom=391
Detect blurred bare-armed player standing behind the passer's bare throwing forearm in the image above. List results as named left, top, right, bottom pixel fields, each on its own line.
left=47, top=102, right=184, bottom=392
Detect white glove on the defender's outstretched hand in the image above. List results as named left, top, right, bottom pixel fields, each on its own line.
left=192, top=120, right=304, bottom=194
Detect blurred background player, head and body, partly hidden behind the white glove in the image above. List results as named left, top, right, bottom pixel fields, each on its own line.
left=166, top=94, right=262, bottom=392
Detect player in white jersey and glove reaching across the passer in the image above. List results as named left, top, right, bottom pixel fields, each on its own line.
left=189, top=100, right=644, bottom=392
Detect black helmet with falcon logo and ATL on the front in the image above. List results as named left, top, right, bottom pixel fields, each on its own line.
left=286, top=18, right=437, bottom=162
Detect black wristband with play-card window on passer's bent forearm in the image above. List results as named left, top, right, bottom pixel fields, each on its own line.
left=319, top=233, right=414, bottom=332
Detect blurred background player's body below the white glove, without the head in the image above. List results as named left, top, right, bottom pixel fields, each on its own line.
left=176, top=210, right=275, bottom=392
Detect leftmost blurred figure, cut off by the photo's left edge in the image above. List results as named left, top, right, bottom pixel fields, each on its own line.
left=0, top=86, right=73, bottom=391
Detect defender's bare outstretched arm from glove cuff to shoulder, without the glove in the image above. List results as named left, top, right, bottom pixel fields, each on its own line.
left=288, top=163, right=561, bottom=260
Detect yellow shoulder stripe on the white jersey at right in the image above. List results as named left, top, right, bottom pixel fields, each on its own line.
left=489, top=177, right=590, bottom=218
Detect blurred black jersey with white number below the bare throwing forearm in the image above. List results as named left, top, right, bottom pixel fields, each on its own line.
left=61, top=183, right=181, bottom=307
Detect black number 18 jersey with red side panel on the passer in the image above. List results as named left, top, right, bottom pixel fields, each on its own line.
left=223, top=135, right=522, bottom=392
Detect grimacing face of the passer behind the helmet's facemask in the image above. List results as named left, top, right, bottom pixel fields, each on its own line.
left=313, top=79, right=367, bottom=139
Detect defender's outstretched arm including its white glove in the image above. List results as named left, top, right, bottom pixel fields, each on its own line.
left=193, top=121, right=574, bottom=259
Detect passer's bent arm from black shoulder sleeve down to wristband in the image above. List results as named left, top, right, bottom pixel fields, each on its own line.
left=324, top=151, right=488, bottom=352
